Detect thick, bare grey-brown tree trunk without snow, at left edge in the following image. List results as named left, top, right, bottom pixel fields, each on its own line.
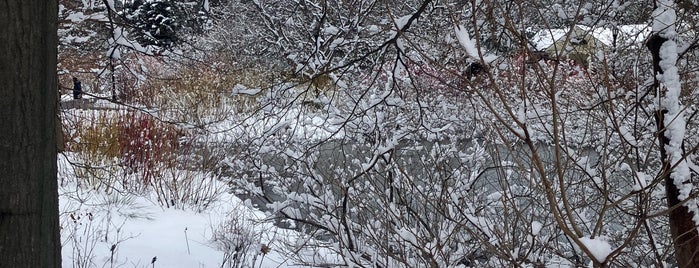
left=0, top=0, right=61, bottom=268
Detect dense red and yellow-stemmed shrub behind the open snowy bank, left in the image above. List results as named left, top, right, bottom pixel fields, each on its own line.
left=65, top=111, right=179, bottom=188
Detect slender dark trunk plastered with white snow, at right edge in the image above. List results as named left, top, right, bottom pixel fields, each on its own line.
left=647, top=0, right=699, bottom=267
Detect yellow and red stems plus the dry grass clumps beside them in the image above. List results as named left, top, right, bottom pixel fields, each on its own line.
left=65, top=110, right=223, bottom=209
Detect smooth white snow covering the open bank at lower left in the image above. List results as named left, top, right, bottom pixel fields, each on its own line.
left=59, top=170, right=292, bottom=267
